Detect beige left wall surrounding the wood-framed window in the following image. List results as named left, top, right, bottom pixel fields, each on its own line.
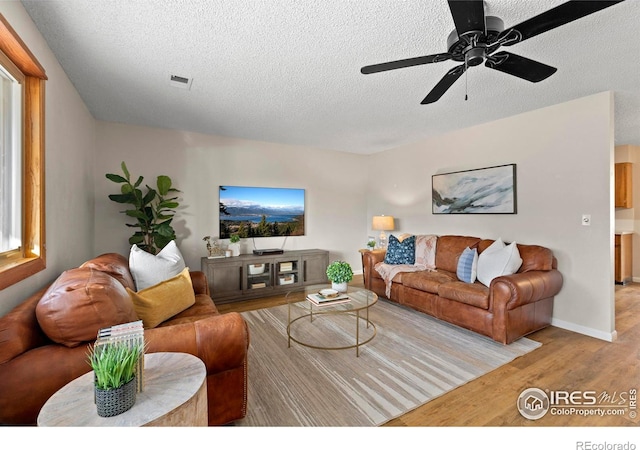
left=0, top=2, right=95, bottom=315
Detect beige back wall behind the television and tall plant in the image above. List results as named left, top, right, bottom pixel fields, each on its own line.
left=95, top=122, right=368, bottom=270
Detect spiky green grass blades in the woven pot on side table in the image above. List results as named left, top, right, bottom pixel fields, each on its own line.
left=87, top=343, right=144, bottom=390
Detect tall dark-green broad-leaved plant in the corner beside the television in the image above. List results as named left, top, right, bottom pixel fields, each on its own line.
left=106, top=161, right=180, bottom=255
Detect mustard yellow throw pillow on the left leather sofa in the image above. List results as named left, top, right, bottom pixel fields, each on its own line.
left=127, top=267, right=196, bottom=328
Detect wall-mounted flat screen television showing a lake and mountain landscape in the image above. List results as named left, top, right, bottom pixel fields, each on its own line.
left=220, top=186, right=304, bottom=239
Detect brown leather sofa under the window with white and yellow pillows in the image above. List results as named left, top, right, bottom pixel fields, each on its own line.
left=0, top=253, right=249, bottom=425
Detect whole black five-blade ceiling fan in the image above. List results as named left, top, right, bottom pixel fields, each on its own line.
left=360, top=0, right=624, bottom=105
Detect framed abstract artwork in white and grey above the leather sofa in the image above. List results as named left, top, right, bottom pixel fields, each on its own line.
left=431, top=164, right=517, bottom=214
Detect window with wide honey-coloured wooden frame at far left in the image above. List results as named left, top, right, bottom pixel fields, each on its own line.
left=0, top=15, right=47, bottom=289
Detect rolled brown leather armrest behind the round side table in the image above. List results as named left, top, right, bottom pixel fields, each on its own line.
left=144, top=312, right=249, bottom=375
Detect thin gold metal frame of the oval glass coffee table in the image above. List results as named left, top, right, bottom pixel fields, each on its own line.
left=286, top=285, right=378, bottom=356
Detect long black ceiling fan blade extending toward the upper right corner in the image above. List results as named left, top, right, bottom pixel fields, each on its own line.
left=498, top=0, right=624, bottom=45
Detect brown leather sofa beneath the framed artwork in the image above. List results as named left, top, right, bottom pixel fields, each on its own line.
left=363, top=236, right=563, bottom=344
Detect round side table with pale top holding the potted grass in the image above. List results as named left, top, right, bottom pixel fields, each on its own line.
left=38, top=353, right=208, bottom=427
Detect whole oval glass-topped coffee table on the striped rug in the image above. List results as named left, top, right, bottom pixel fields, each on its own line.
left=286, top=285, right=378, bottom=356
